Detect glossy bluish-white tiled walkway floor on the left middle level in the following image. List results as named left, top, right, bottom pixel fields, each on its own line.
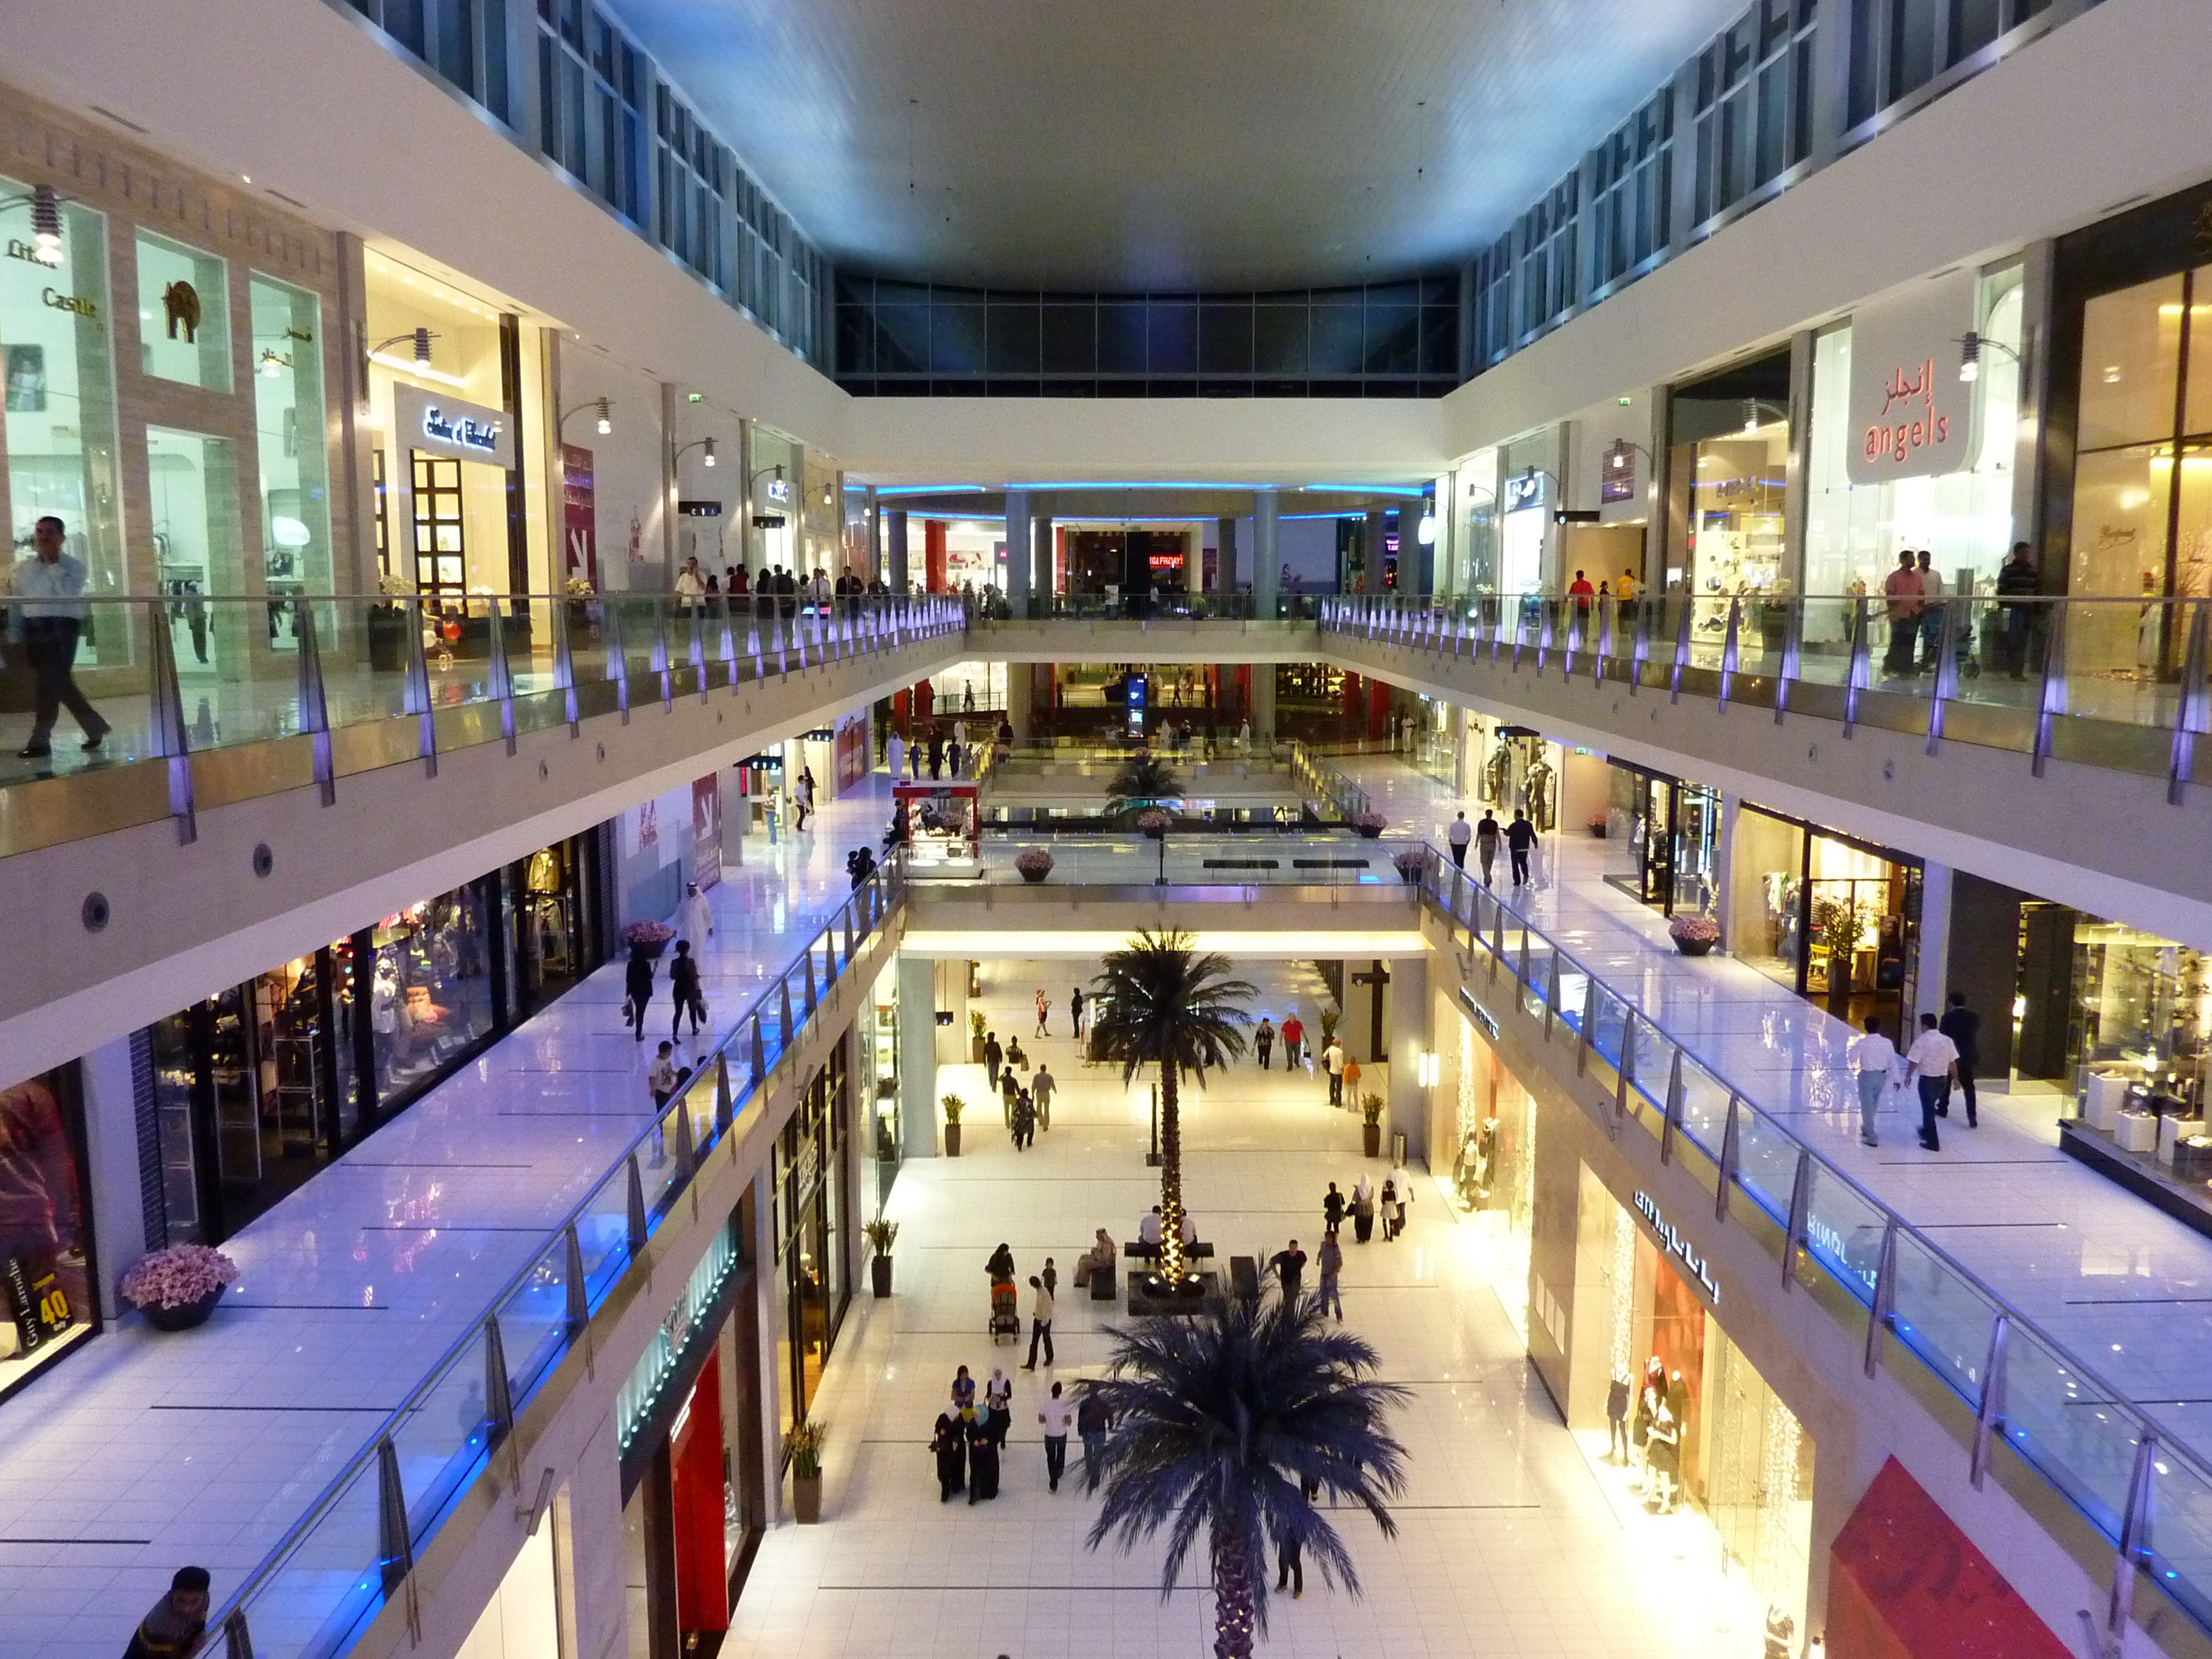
left=0, top=774, right=889, bottom=1659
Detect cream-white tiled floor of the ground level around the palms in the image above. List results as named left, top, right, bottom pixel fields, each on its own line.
left=730, top=962, right=1758, bottom=1659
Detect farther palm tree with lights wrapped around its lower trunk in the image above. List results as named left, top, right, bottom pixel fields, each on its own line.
left=1093, top=929, right=1259, bottom=1290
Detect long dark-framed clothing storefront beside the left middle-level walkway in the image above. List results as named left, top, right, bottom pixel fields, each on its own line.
left=139, top=832, right=606, bottom=1243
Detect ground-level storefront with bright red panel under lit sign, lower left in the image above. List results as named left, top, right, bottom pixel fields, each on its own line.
left=615, top=1192, right=768, bottom=1659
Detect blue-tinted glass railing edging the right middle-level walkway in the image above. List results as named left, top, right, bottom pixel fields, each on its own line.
left=1418, top=851, right=2212, bottom=1654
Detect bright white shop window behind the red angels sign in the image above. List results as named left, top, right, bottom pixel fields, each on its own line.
left=1805, top=266, right=2026, bottom=648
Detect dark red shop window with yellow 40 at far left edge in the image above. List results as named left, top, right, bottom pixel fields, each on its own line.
left=0, top=1064, right=99, bottom=1396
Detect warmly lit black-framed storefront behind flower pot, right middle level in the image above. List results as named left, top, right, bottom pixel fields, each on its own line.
left=1728, top=805, right=1920, bottom=1037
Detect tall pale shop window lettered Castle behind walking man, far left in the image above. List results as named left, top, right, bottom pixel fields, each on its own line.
left=0, top=179, right=130, bottom=610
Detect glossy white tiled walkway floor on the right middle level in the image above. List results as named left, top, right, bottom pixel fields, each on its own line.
left=1345, top=757, right=2212, bottom=1458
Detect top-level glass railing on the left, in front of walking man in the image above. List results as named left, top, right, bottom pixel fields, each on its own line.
left=0, top=593, right=965, bottom=827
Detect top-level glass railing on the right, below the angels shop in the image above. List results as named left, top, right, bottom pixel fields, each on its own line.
left=1321, top=593, right=2212, bottom=788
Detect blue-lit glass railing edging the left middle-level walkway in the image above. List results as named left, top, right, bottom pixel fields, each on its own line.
left=208, top=870, right=907, bottom=1659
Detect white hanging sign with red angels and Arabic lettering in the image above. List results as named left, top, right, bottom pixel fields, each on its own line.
left=1847, top=272, right=1973, bottom=484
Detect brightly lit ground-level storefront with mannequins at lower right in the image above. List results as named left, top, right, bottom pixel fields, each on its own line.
left=1568, top=1164, right=1814, bottom=1659
